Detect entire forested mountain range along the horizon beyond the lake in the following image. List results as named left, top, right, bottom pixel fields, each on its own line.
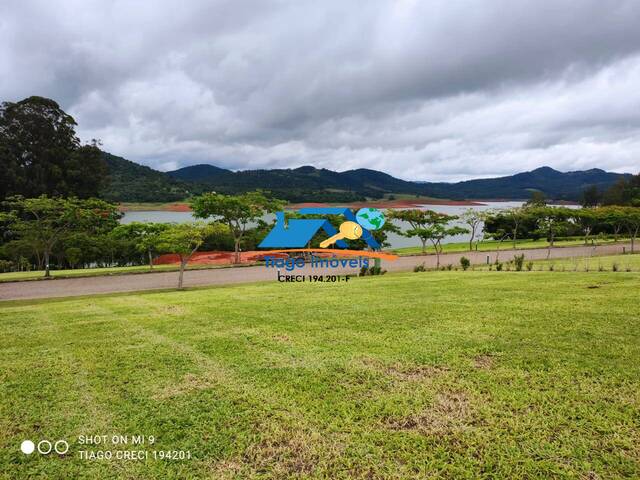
left=103, top=153, right=631, bottom=202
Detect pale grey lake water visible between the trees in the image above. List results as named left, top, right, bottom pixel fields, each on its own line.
left=121, top=202, right=536, bottom=248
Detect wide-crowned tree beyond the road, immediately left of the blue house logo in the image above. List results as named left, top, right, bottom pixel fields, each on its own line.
left=191, top=191, right=284, bottom=263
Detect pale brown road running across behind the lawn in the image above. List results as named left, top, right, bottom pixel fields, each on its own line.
left=0, top=244, right=629, bottom=300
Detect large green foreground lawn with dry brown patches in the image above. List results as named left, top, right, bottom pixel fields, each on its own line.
left=0, top=272, right=640, bottom=479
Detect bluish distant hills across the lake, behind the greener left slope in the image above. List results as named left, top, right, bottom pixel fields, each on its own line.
left=167, top=165, right=630, bottom=201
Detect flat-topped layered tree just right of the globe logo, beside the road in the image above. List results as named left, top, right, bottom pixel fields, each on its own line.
left=390, top=209, right=468, bottom=267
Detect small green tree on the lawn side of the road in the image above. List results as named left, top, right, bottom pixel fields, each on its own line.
left=157, top=222, right=227, bottom=288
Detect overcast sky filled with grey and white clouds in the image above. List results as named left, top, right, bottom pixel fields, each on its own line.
left=0, top=0, right=640, bottom=181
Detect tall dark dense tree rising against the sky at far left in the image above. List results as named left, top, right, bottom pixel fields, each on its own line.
left=0, top=97, right=107, bottom=198
